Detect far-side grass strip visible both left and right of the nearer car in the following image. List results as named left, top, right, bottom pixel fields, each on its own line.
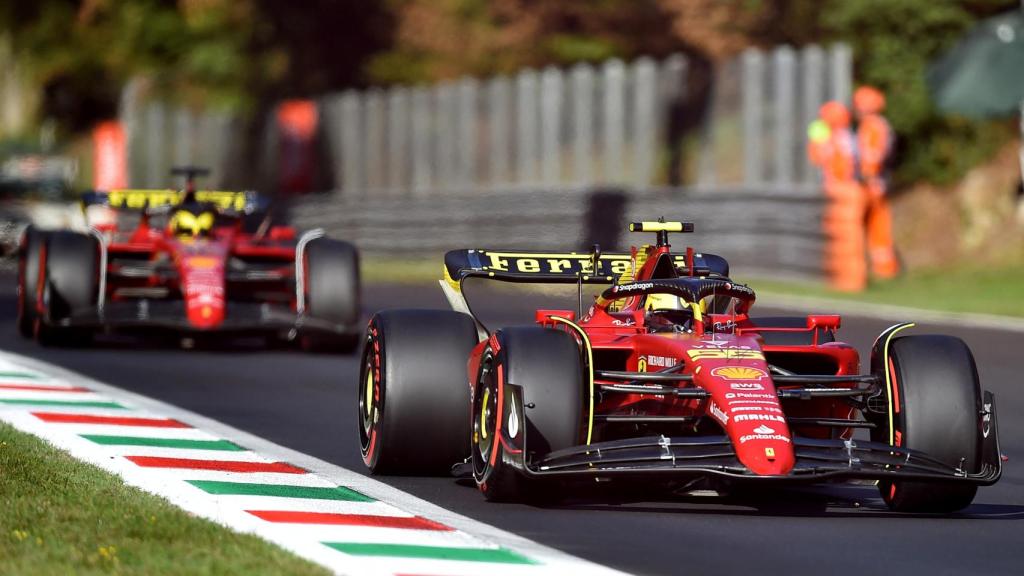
left=362, top=255, right=1024, bottom=317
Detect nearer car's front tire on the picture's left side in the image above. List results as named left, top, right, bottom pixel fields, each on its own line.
left=472, top=326, right=589, bottom=501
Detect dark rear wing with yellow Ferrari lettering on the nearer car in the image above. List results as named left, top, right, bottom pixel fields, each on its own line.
left=444, top=249, right=729, bottom=289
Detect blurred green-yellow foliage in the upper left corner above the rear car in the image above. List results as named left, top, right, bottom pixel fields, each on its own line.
left=0, top=0, right=287, bottom=130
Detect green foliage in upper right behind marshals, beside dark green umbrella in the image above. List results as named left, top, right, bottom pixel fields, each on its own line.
left=822, top=0, right=1018, bottom=183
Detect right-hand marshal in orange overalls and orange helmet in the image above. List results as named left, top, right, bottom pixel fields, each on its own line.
left=853, top=86, right=899, bottom=278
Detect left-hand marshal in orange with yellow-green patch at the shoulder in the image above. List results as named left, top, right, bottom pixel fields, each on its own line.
left=807, top=101, right=867, bottom=292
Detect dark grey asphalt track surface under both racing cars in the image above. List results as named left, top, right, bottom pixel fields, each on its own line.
left=0, top=274, right=1024, bottom=576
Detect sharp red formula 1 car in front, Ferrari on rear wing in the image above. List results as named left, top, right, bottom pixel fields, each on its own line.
left=358, top=222, right=1001, bottom=512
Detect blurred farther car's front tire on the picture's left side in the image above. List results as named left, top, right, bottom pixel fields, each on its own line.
left=35, top=231, right=99, bottom=346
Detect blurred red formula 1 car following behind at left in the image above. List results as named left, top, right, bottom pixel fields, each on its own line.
left=17, top=163, right=361, bottom=351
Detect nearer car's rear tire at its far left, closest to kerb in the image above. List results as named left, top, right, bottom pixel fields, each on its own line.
left=357, top=310, right=478, bottom=476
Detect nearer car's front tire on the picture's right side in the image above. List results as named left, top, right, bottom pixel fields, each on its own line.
left=871, top=335, right=982, bottom=513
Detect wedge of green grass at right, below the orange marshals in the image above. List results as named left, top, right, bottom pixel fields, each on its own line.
left=750, top=265, right=1024, bottom=317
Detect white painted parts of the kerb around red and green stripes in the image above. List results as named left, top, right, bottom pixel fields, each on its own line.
left=0, top=351, right=622, bottom=576
